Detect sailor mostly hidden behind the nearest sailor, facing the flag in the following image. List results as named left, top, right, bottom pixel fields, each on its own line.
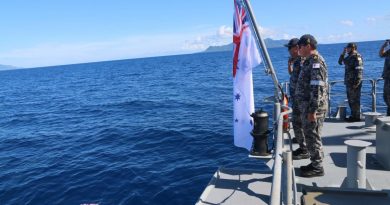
left=284, top=38, right=310, bottom=160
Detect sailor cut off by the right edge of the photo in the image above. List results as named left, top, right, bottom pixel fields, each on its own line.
left=379, top=40, right=390, bottom=116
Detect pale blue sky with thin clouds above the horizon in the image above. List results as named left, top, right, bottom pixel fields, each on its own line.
left=0, top=0, right=390, bottom=68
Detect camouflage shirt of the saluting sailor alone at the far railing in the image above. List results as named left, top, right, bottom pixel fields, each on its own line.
left=339, top=51, right=363, bottom=86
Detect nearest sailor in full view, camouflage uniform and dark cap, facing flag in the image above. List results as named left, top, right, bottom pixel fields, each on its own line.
left=295, top=34, right=328, bottom=177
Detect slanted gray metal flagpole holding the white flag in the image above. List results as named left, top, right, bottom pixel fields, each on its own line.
left=243, top=0, right=282, bottom=103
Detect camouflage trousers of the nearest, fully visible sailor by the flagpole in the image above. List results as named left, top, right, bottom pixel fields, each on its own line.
left=301, top=112, right=325, bottom=168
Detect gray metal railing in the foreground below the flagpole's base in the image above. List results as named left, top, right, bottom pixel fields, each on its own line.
left=269, top=103, right=297, bottom=205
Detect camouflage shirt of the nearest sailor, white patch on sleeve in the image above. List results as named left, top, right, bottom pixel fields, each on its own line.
left=295, top=53, right=328, bottom=113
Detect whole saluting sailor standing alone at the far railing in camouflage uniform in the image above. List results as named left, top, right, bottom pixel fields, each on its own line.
left=339, top=43, right=363, bottom=122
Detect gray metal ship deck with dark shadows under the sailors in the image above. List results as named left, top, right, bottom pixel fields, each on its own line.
left=197, top=119, right=390, bottom=205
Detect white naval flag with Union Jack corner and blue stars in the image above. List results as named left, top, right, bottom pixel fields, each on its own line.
left=233, top=0, right=261, bottom=150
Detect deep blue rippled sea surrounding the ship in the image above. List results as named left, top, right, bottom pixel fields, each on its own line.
left=0, top=41, right=383, bottom=205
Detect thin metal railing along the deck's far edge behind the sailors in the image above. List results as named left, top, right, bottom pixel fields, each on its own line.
left=282, top=78, right=385, bottom=117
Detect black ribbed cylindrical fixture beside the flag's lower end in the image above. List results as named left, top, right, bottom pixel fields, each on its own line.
left=250, top=110, right=270, bottom=156
